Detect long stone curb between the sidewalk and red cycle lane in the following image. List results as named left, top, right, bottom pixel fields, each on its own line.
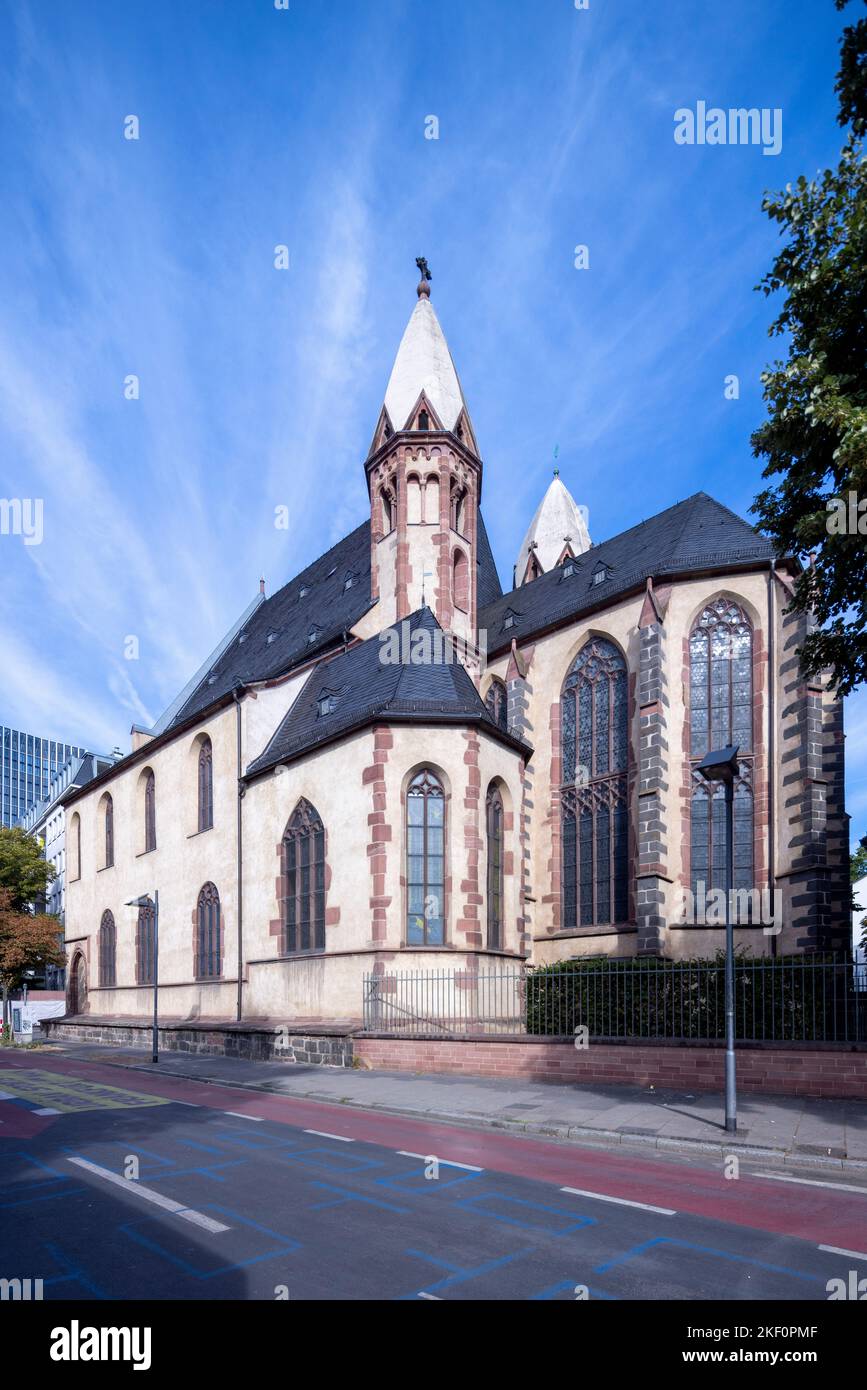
left=48, top=1058, right=867, bottom=1173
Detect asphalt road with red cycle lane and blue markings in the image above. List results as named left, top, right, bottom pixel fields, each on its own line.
left=0, top=1052, right=867, bottom=1302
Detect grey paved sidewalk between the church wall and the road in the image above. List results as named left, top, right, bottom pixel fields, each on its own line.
left=32, top=1043, right=867, bottom=1172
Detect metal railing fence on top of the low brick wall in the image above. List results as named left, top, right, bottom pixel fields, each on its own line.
left=364, top=956, right=867, bottom=1043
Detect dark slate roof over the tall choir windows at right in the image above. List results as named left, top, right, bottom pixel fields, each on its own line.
left=478, top=492, right=774, bottom=653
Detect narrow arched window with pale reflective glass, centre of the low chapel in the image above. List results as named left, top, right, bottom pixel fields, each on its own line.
left=406, top=767, right=446, bottom=947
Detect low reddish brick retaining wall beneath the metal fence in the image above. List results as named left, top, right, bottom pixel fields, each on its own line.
left=354, top=1037, right=867, bottom=1099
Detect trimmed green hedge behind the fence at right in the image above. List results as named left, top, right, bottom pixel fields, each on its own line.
left=527, top=952, right=867, bottom=1041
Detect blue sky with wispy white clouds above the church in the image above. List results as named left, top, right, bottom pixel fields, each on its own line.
left=0, top=0, right=867, bottom=834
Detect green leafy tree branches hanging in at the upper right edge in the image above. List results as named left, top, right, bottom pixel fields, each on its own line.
left=752, top=0, right=867, bottom=695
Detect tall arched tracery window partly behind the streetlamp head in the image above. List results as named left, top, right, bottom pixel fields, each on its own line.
left=689, top=596, right=753, bottom=899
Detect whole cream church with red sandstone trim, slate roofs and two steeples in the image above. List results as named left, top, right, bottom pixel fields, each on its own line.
left=65, top=268, right=848, bottom=1020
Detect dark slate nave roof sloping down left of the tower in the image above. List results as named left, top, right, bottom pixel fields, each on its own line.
left=170, top=521, right=371, bottom=728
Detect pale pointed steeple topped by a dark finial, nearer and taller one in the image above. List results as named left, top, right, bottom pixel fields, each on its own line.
left=385, top=271, right=472, bottom=432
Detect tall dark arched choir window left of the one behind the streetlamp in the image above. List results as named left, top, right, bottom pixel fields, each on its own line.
left=560, top=637, right=629, bottom=927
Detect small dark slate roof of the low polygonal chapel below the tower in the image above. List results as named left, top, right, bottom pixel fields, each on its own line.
left=247, top=607, right=528, bottom=776
